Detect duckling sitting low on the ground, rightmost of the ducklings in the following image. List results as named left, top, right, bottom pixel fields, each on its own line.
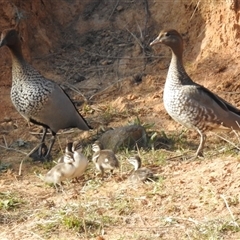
left=128, top=155, right=153, bottom=182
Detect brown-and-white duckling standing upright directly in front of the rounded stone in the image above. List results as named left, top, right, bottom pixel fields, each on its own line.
left=92, top=143, right=119, bottom=178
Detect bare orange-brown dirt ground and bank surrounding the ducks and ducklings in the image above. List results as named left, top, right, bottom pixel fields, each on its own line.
left=0, top=0, right=240, bottom=240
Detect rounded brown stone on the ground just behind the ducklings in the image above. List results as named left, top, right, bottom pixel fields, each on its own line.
left=99, top=125, right=147, bottom=152
